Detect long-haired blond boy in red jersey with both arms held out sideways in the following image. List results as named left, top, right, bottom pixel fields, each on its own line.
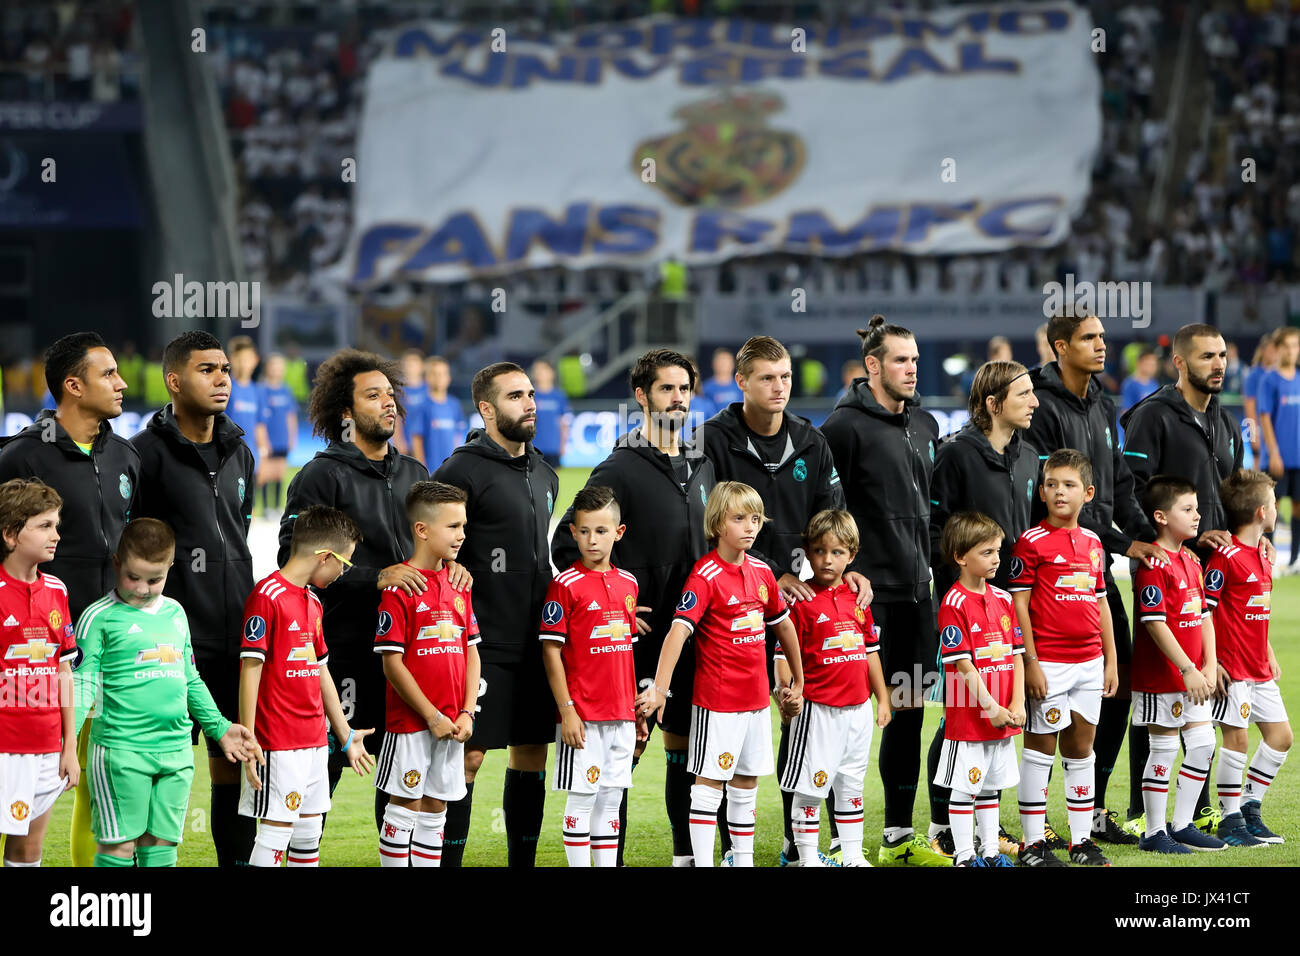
left=637, top=481, right=803, bottom=866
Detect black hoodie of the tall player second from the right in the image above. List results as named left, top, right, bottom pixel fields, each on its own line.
left=1024, top=362, right=1156, bottom=554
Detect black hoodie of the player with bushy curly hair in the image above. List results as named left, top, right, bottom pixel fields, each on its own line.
left=278, top=441, right=429, bottom=658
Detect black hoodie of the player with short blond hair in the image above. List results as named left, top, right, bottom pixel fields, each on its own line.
left=701, top=402, right=844, bottom=579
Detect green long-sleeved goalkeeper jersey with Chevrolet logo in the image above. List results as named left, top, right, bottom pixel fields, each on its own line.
left=75, top=588, right=230, bottom=753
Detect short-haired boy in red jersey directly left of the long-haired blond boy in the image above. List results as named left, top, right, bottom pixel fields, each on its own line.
left=541, top=485, right=650, bottom=866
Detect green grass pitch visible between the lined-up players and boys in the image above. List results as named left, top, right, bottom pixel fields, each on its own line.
left=35, top=468, right=1300, bottom=866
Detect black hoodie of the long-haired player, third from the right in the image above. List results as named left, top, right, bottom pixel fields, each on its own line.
left=930, top=423, right=1039, bottom=598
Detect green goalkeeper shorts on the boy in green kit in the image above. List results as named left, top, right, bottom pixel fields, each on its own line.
left=86, top=744, right=194, bottom=843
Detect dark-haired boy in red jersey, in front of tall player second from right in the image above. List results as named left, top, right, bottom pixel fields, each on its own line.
left=1008, top=449, right=1119, bottom=866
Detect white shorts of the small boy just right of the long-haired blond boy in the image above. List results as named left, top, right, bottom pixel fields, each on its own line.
left=781, top=700, right=876, bottom=799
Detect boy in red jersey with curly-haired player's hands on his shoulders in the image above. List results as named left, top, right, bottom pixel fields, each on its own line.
left=374, top=481, right=481, bottom=866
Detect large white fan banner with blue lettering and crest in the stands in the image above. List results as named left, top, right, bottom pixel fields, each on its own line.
left=335, top=3, right=1101, bottom=284
